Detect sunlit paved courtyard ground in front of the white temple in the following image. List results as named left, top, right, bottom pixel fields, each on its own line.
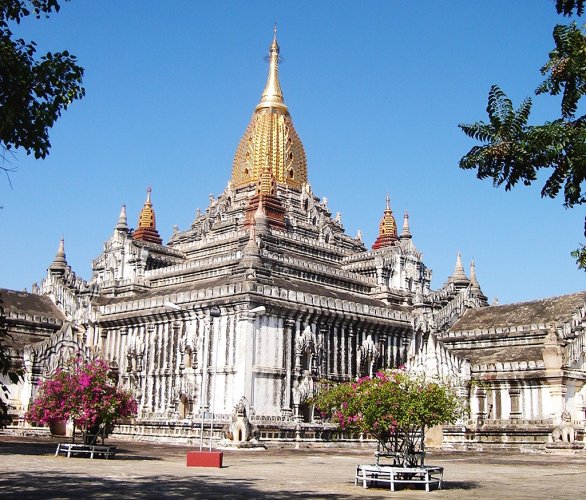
left=0, top=435, right=586, bottom=500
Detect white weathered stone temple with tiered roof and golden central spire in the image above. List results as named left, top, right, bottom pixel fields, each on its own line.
left=0, top=33, right=586, bottom=446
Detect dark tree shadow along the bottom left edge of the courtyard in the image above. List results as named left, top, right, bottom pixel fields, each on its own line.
left=0, top=472, right=356, bottom=500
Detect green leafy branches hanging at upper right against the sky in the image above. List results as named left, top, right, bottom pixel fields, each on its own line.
left=459, top=0, right=586, bottom=270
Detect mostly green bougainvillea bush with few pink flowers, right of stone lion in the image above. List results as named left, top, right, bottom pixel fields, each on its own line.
left=313, top=370, right=464, bottom=464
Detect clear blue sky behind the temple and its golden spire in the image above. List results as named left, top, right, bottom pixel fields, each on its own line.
left=0, top=0, right=586, bottom=303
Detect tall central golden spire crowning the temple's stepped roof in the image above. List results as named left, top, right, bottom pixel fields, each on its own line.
left=231, top=26, right=307, bottom=189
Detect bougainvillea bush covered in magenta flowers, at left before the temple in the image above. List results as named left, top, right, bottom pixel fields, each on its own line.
left=26, top=358, right=137, bottom=440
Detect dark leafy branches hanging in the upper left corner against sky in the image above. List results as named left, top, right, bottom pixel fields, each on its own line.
left=0, top=0, right=85, bottom=160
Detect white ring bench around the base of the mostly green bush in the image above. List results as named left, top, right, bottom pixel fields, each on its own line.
left=354, top=464, right=444, bottom=491
